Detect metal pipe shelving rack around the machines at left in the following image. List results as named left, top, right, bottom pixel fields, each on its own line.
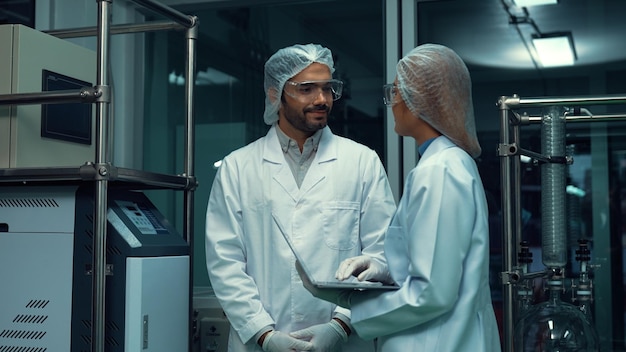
left=0, top=0, right=198, bottom=352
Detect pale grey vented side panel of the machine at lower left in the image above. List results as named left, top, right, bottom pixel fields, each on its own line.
left=0, top=187, right=74, bottom=351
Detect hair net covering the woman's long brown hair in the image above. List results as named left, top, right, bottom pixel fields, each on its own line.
left=396, top=44, right=481, bottom=158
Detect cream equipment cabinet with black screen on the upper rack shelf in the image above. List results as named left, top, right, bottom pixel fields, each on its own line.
left=0, top=24, right=96, bottom=168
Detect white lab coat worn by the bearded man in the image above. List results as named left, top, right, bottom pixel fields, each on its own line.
left=206, top=125, right=395, bottom=352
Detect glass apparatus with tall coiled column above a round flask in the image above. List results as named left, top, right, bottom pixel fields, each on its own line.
left=513, top=107, right=600, bottom=352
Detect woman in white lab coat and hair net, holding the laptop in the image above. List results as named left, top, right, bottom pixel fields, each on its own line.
left=298, top=44, right=501, bottom=352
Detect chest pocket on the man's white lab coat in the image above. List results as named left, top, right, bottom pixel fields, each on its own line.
left=322, top=201, right=360, bottom=250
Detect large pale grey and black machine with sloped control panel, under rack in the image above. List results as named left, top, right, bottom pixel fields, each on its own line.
left=0, top=183, right=190, bottom=352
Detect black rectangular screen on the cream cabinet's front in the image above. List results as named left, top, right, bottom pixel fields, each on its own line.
left=41, top=70, right=92, bottom=145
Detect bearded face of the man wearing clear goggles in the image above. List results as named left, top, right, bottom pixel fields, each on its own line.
left=278, top=62, right=333, bottom=136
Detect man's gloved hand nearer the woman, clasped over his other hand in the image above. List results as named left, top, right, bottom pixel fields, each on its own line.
left=289, top=319, right=348, bottom=352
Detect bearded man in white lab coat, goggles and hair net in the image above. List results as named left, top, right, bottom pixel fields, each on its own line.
left=206, top=44, right=395, bottom=352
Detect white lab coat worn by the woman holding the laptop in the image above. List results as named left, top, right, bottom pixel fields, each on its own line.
left=352, top=136, right=500, bottom=352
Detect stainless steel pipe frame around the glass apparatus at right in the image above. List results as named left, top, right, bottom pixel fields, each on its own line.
left=497, top=95, right=626, bottom=351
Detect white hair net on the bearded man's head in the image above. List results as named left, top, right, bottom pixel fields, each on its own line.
left=263, top=44, right=335, bottom=125
